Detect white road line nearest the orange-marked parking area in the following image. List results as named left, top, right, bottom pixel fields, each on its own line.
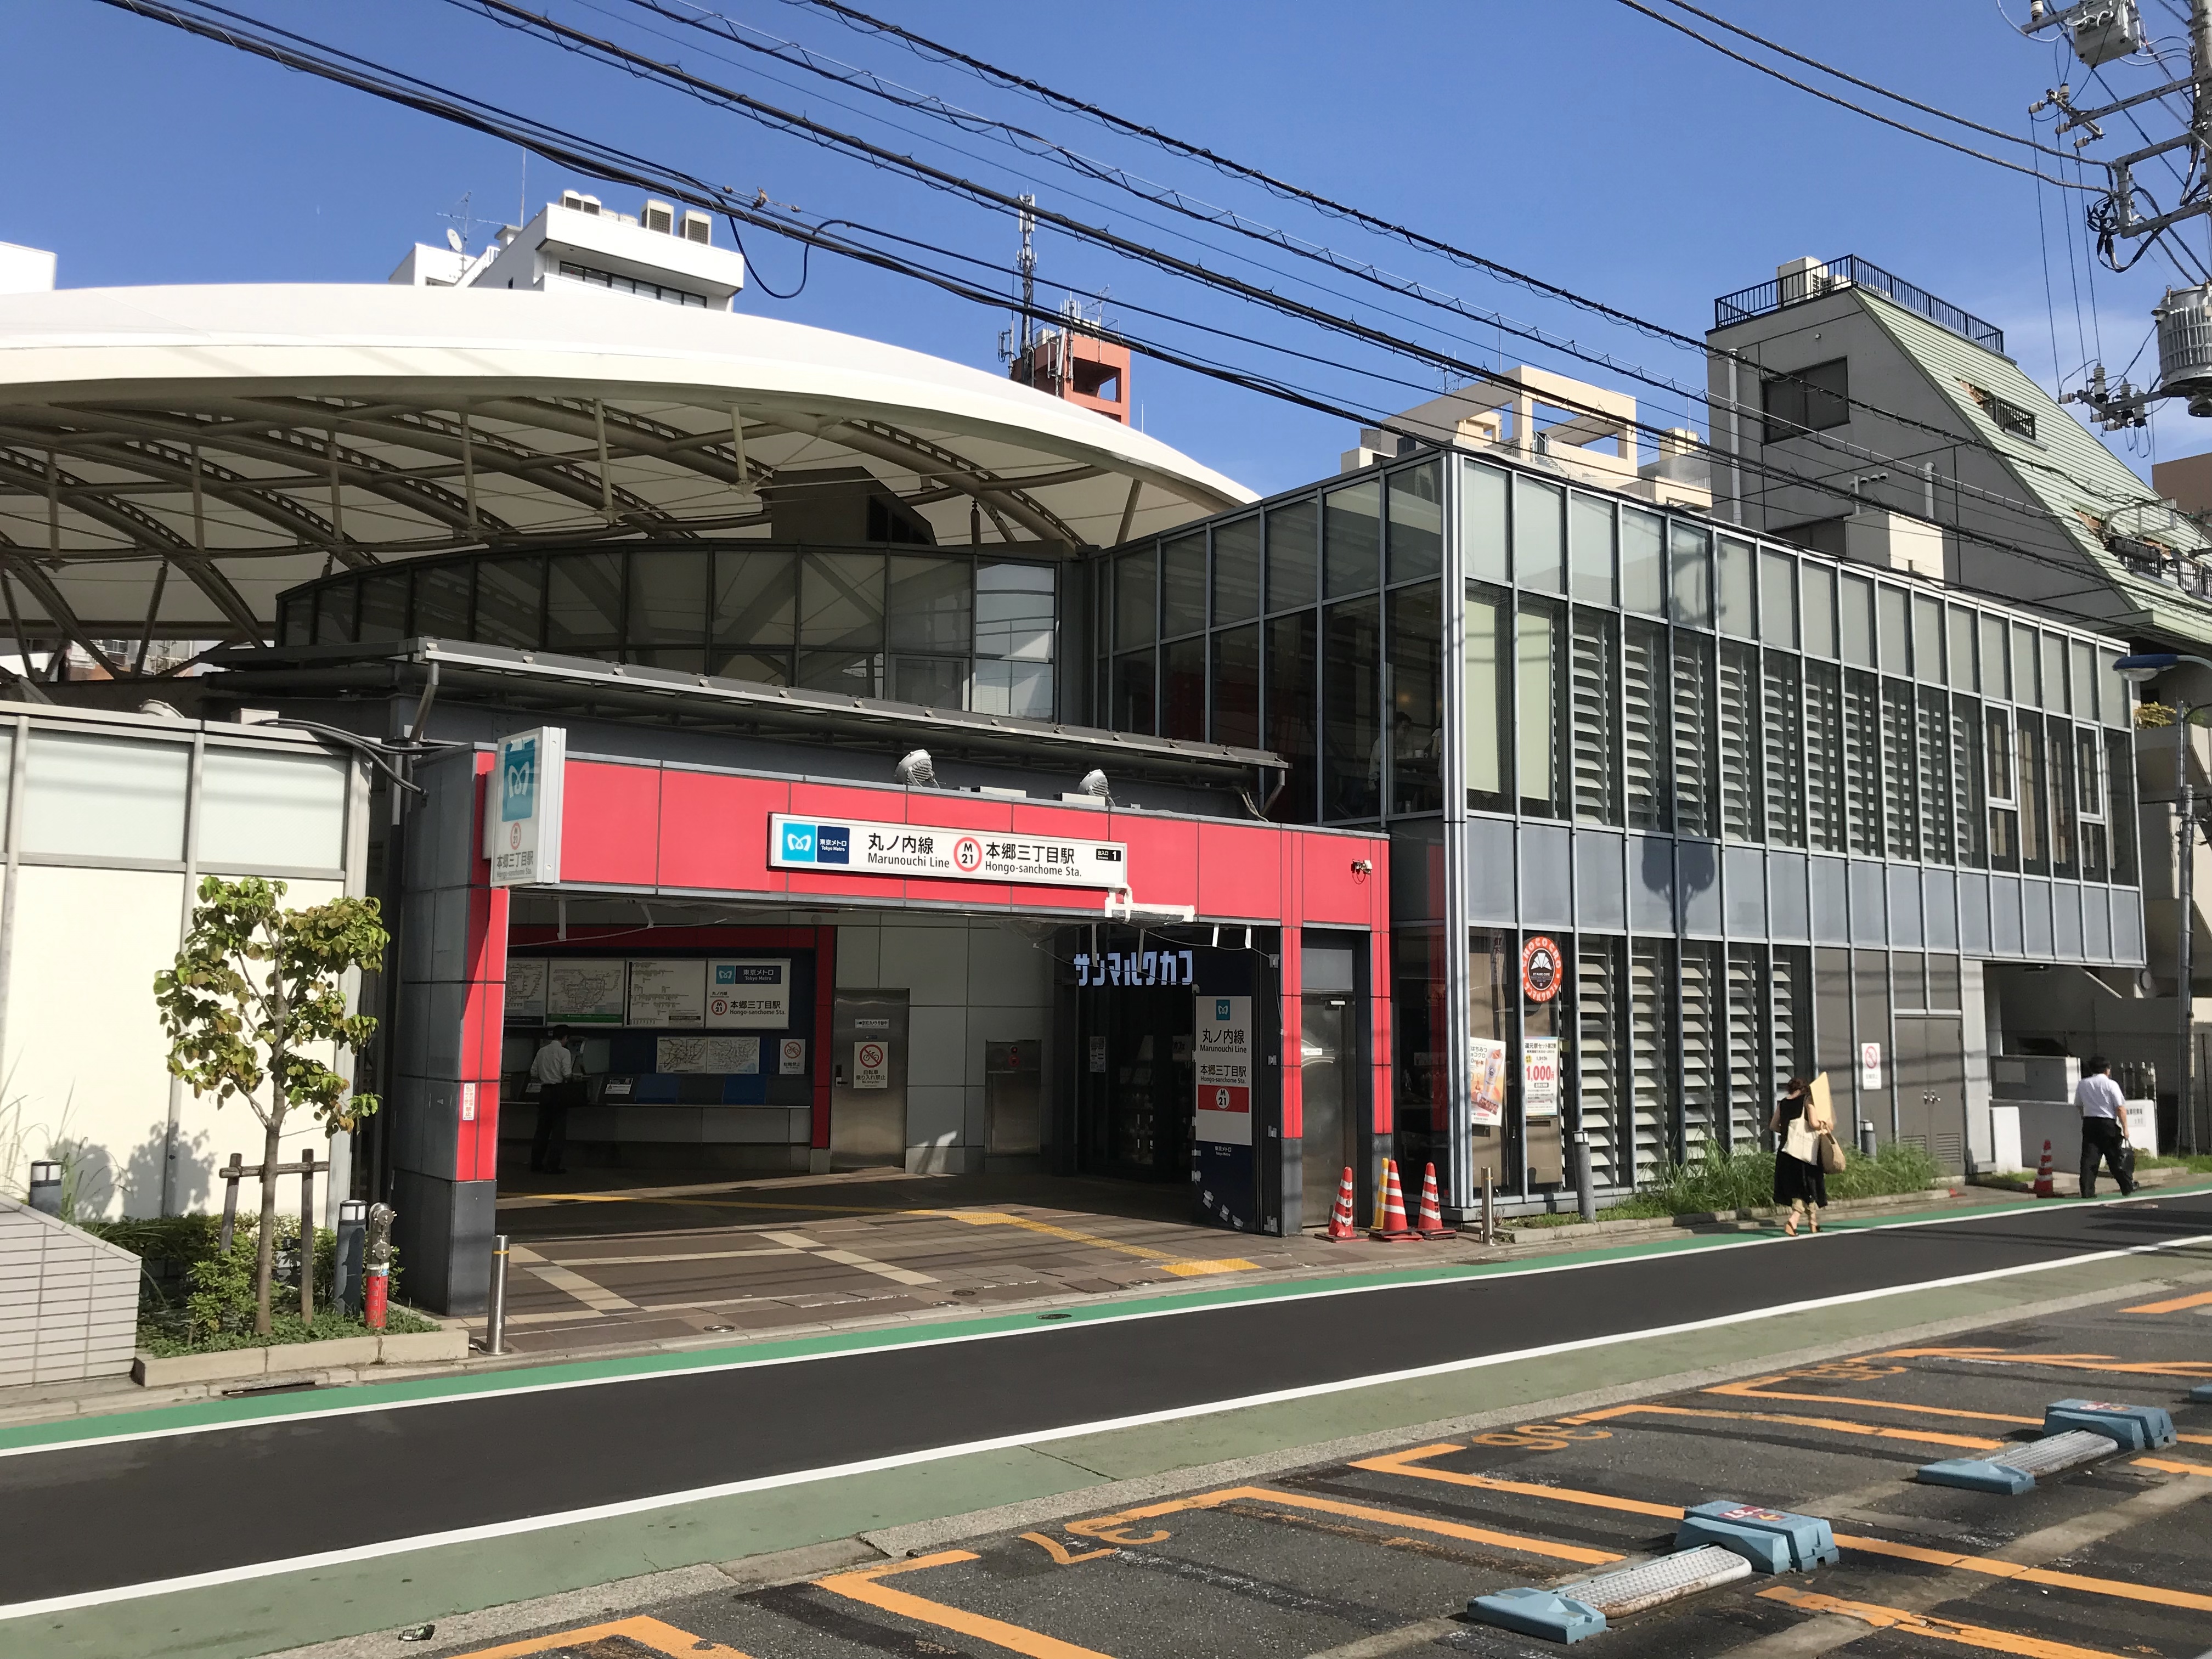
left=0, top=1234, right=2212, bottom=1619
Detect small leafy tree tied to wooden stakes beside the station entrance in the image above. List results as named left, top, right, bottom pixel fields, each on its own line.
left=153, top=876, right=387, bottom=1336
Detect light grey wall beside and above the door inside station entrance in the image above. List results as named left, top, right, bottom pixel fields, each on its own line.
left=836, top=913, right=1053, bottom=1172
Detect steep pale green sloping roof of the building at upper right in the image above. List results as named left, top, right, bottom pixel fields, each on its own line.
left=1852, top=287, right=2212, bottom=644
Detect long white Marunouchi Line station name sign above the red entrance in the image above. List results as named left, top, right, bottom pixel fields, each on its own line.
left=768, top=812, right=1128, bottom=889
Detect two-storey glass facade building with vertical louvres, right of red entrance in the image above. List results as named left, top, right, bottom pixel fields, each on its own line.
left=1093, top=452, right=2143, bottom=1205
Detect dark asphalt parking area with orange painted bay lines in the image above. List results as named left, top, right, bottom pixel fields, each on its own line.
left=340, top=1274, right=2212, bottom=1659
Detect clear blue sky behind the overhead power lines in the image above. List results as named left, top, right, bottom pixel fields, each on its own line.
left=0, top=0, right=2212, bottom=489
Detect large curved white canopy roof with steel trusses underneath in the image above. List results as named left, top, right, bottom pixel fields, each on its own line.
left=0, top=285, right=1252, bottom=639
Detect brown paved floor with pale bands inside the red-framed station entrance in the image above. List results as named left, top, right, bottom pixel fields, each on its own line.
left=487, top=1170, right=1531, bottom=1354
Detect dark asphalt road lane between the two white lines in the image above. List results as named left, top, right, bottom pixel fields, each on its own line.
left=0, top=1194, right=2212, bottom=1606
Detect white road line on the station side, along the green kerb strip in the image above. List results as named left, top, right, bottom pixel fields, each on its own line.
left=0, top=1197, right=2212, bottom=1458
